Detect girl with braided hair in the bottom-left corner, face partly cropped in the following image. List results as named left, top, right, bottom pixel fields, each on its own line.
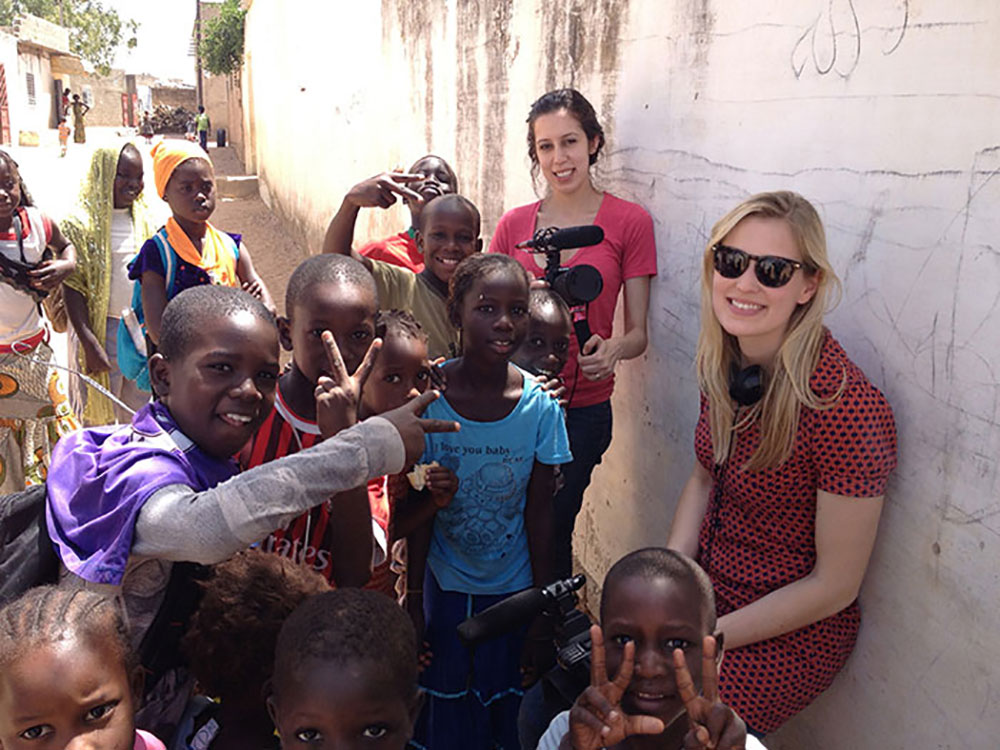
left=0, top=586, right=164, bottom=750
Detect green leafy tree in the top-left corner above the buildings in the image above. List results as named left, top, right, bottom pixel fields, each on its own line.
left=0, top=0, right=139, bottom=75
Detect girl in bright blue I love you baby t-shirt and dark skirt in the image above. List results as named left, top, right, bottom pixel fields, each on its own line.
left=409, top=254, right=572, bottom=750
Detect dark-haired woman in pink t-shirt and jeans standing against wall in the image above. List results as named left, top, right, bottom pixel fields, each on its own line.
left=490, top=89, right=656, bottom=577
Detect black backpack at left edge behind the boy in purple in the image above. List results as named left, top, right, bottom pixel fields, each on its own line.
left=0, top=484, right=59, bottom=607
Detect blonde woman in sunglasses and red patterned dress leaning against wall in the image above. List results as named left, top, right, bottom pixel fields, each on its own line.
left=668, top=192, right=896, bottom=736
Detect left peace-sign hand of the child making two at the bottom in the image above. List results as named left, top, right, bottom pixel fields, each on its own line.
left=560, top=625, right=665, bottom=750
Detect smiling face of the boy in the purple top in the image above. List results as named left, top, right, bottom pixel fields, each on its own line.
left=150, top=311, right=278, bottom=458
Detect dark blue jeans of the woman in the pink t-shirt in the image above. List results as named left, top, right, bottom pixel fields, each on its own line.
left=552, top=401, right=611, bottom=578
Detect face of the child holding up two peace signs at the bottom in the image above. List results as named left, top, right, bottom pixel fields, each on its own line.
left=601, top=576, right=707, bottom=726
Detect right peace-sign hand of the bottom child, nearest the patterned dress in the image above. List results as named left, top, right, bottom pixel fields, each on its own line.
left=674, top=635, right=747, bottom=750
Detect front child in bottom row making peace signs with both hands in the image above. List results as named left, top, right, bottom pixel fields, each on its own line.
left=538, top=547, right=762, bottom=750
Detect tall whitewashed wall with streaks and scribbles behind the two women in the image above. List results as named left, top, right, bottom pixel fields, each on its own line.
left=244, top=0, right=1000, bottom=749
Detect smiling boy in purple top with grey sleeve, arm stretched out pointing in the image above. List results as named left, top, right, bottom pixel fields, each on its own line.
left=47, top=286, right=458, bottom=736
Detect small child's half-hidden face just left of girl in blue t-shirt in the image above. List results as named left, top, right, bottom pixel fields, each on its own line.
left=361, top=335, right=431, bottom=414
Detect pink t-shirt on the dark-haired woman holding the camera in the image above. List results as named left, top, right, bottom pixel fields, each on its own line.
left=490, top=193, right=656, bottom=408
